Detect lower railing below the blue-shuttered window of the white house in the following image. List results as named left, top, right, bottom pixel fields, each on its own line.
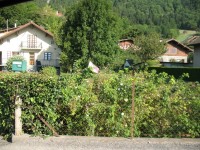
left=36, top=59, right=60, bottom=67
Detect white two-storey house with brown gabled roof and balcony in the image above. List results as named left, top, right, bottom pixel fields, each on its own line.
left=0, top=22, right=61, bottom=70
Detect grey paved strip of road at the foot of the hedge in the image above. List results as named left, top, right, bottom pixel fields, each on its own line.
left=0, top=135, right=200, bottom=150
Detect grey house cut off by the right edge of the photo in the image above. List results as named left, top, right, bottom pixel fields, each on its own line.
left=189, top=36, right=200, bottom=67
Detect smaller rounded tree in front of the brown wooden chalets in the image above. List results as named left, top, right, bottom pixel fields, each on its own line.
left=131, top=33, right=165, bottom=63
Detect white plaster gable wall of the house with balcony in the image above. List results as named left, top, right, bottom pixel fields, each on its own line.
left=0, top=26, right=61, bottom=69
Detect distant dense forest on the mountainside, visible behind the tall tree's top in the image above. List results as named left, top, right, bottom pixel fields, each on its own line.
left=44, top=0, right=200, bottom=30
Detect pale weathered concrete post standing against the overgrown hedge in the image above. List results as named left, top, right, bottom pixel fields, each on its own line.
left=15, top=95, right=22, bottom=136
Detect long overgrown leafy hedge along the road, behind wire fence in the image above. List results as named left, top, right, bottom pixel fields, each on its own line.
left=0, top=72, right=200, bottom=137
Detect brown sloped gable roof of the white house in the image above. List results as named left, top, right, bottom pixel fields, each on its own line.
left=0, top=21, right=53, bottom=40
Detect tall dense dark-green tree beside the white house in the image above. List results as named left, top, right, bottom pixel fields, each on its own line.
left=61, top=0, right=121, bottom=70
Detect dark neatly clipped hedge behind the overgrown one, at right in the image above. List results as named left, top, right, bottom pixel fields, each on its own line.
left=149, top=67, right=200, bottom=82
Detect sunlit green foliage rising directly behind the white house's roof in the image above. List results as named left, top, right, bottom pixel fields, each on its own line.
left=0, top=2, right=64, bottom=45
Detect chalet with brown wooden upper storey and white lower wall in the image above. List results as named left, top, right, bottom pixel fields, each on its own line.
left=160, top=39, right=193, bottom=63
